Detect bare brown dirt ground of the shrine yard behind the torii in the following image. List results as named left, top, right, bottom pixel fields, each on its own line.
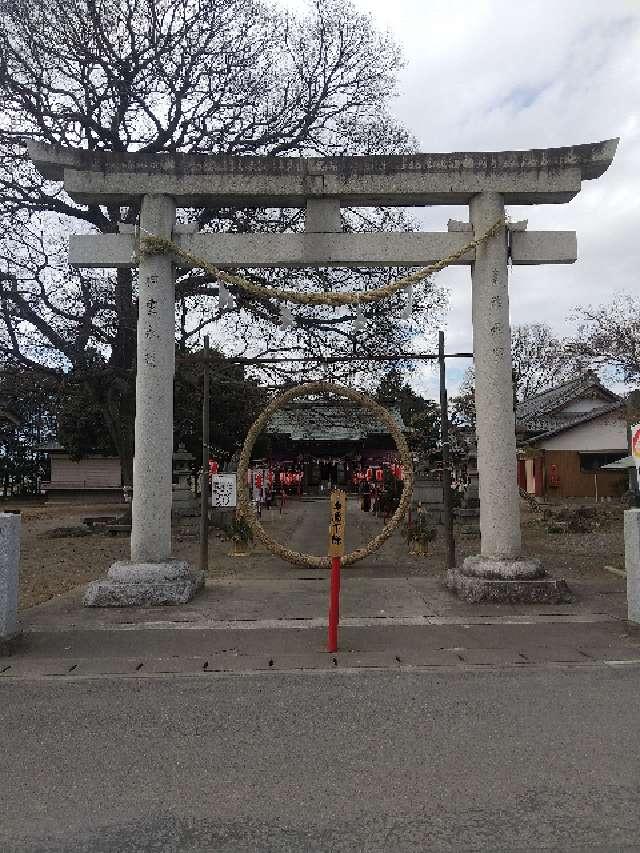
left=6, top=492, right=624, bottom=609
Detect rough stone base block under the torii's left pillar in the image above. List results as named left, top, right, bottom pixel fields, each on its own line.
left=83, top=560, right=204, bottom=607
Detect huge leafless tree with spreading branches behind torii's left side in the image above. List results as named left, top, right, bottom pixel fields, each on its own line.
left=0, top=0, right=440, bottom=480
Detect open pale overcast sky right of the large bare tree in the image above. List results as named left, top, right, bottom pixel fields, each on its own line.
left=282, top=0, right=640, bottom=400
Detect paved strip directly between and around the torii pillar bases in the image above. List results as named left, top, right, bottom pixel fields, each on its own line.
left=20, top=572, right=626, bottom=631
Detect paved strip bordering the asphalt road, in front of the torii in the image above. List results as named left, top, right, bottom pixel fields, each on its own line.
left=0, top=621, right=640, bottom=678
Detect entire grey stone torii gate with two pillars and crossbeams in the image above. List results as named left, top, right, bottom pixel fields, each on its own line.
left=29, top=139, right=618, bottom=605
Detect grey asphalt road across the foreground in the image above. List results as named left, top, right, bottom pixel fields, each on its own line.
left=0, top=665, right=640, bottom=853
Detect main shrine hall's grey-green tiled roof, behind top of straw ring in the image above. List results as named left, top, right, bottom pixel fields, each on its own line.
left=266, top=400, right=406, bottom=441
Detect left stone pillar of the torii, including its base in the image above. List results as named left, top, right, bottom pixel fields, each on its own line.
left=84, top=194, right=204, bottom=607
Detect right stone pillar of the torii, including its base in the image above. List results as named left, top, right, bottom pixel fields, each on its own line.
left=447, top=192, right=552, bottom=601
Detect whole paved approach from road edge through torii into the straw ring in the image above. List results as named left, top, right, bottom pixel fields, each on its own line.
left=5, top=492, right=640, bottom=679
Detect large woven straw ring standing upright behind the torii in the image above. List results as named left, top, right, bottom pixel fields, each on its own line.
left=237, top=382, right=413, bottom=569
